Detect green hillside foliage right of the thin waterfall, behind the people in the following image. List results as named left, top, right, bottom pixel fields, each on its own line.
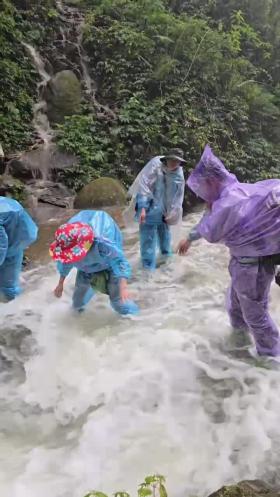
left=59, top=0, right=280, bottom=187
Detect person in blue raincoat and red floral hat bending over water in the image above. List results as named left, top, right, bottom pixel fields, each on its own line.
left=50, top=210, right=138, bottom=315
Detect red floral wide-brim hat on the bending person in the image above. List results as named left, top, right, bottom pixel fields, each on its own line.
left=49, top=223, right=94, bottom=264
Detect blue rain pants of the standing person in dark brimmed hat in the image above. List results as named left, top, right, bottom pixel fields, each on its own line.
left=140, top=223, right=172, bottom=271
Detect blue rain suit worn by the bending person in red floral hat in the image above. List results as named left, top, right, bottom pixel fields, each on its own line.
left=57, top=211, right=139, bottom=315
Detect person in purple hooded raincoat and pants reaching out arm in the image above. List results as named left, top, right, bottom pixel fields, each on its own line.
left=178, top=145, right=280, bottom=357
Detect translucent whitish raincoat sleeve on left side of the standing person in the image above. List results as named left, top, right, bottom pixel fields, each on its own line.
left=137, top=157, right=161, bottom=209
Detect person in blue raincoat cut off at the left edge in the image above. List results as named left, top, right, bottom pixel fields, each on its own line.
left=0, top=196, right=38, bottom=300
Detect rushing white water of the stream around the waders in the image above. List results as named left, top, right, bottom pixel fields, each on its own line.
left=0, top=216, right=280, bottom=497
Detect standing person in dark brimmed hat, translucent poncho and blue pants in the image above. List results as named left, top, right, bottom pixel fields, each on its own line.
left=129, top=148, right=186, bottom=270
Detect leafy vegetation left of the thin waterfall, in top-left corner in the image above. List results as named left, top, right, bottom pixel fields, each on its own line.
left=0, top=0, right=60, bottom=154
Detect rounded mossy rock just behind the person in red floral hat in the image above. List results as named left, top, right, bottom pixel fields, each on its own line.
left=74, top=178, right=126, bottom=209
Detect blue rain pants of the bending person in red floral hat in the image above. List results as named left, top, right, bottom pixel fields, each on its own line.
left=73, top=271, right=139, bottom=316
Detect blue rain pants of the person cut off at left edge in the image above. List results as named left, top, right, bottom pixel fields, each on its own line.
left=0, top=250, right=23, bottom=300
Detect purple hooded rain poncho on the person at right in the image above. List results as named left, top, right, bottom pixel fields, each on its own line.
left=187, top=145, right=280, bottom=257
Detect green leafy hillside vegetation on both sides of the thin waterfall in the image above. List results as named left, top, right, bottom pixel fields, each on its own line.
left=0, top=0, right=280, bottom=190
